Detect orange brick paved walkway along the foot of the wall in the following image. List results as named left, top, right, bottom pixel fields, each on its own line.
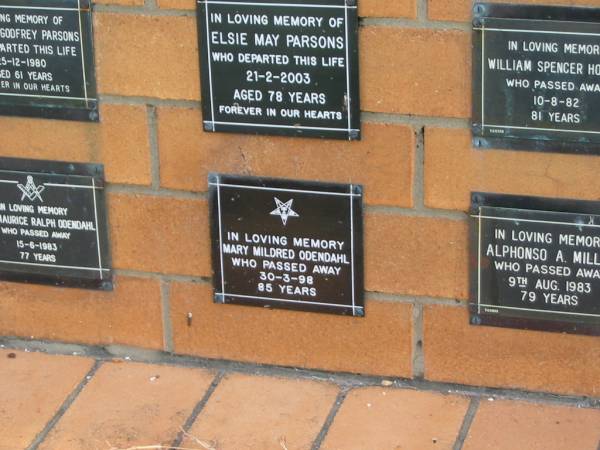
left=0, top=349, right=600, bottom=450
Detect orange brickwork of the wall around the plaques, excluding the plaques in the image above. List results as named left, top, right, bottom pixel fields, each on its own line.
left=0, top=0, right=600, bottom=396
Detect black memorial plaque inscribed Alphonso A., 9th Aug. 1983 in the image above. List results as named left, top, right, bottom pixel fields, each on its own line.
left=470, top=193, right=600, bottom=335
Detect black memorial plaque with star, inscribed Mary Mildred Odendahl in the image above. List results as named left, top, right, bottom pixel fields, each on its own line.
left=209, top=174, right=364, bottom=316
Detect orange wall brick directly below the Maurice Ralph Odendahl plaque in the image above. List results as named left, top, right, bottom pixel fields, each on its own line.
left=0, top=276, right=162, bottom=349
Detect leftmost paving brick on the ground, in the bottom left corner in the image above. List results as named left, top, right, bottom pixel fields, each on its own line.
left=0, top=350, right=93, bottom=450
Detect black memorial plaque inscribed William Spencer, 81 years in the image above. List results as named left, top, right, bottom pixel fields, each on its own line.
left=472, top=3, right=600, bottom=154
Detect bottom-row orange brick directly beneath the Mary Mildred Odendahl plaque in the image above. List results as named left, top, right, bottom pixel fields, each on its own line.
left=171, top=283, right=412, bottom=377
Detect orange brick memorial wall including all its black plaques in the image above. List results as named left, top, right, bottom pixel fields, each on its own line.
left=0, top=0, right=600, bottom=397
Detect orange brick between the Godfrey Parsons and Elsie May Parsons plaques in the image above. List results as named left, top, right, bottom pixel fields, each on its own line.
left=94, top=13, right=200, bottom=100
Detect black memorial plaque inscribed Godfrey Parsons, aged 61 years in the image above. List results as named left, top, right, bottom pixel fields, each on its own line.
left=0, top=0, right=98, bottom=121
